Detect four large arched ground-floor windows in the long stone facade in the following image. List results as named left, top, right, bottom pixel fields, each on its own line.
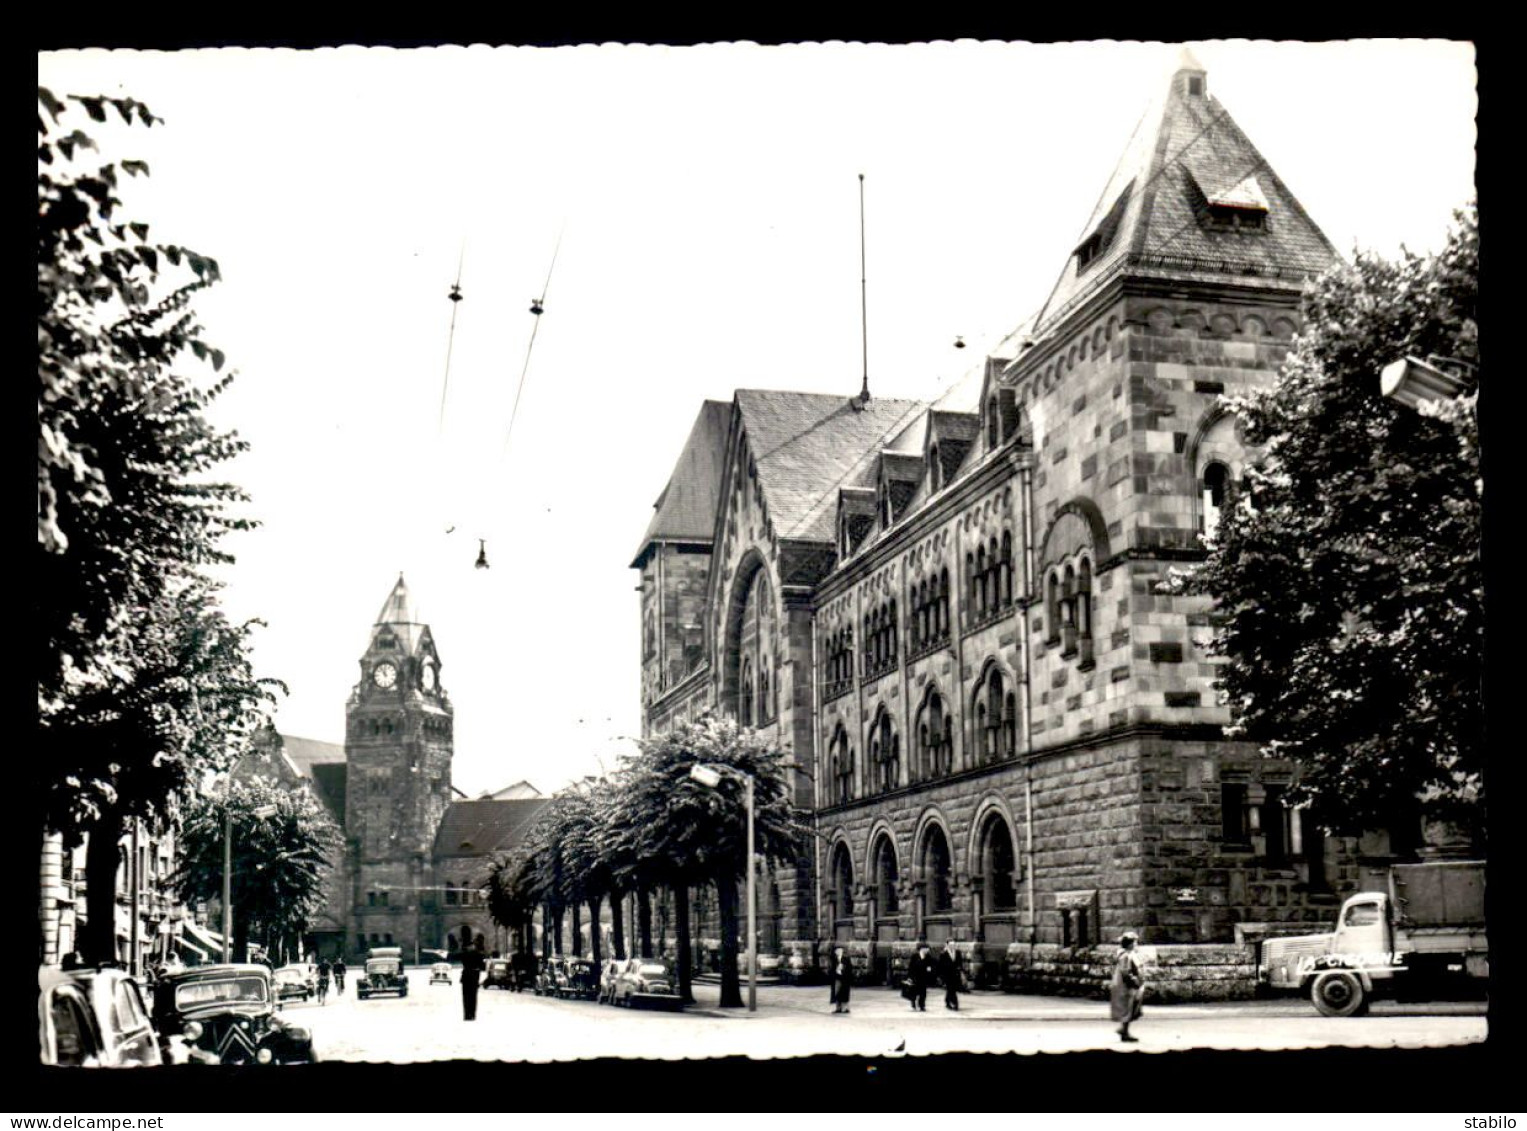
left=828, top=812, right=1022, bottom=922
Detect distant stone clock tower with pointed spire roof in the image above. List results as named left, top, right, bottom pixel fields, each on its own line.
left=345, top=574, right=452, bottom=962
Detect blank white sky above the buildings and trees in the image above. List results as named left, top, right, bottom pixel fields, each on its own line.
left=38, top=41, right=1477, bottom=795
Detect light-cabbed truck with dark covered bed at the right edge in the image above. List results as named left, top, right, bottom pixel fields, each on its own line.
left=1258, top=861, right=1490, bottom=1017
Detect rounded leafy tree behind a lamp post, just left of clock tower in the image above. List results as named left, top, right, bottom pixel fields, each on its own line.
left=174, top=778, right=341, bottom=962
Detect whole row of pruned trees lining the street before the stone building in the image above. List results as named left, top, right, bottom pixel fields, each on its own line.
left=489, top=714, right=808, bottom=1006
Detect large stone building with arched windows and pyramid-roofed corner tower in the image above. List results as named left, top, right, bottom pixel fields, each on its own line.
left=632, top=52, right=1390, bottom=994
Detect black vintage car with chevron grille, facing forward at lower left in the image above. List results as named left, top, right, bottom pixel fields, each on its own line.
left=154, top=963, right=318, bottom=1064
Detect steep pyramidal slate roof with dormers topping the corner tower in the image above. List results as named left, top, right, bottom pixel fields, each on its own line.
left=1035, top=50, right=1336, bottom=333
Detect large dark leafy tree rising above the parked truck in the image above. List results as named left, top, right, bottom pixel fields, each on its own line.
left=1197, top=208, right=1484, bottom=827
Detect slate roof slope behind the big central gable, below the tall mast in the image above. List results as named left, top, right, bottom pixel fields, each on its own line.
left=736, top=389, right=924, bottom=543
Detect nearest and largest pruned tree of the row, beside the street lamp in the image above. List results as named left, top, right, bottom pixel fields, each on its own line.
left=614, top=714, right=805, bottom=1007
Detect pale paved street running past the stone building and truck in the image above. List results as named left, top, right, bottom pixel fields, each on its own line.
left=287, top=971, right=1487, bottom=1062
